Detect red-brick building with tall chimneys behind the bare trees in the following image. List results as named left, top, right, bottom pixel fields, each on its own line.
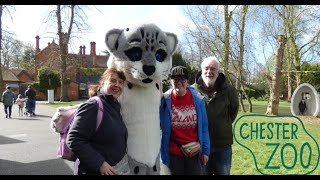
left=35, top=36, right=108, bottom=100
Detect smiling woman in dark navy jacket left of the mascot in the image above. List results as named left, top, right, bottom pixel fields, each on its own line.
left=67, top=68, right=131, bottom=175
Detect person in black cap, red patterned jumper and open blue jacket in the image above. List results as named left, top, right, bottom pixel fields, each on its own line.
left=160, top=66, right=210, bottom=175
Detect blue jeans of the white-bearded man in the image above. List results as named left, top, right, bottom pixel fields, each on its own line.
left=205, top=145, right=232, bottom=175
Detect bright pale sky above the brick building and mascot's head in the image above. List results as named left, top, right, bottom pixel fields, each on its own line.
left=2, top=5, right=189, bottom=55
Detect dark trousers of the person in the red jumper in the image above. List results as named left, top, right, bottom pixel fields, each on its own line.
left=169, top=154, right=201, bottom=175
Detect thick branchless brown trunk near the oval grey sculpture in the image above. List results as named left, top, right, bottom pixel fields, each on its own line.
left=266, top=35, right=286, bottom=115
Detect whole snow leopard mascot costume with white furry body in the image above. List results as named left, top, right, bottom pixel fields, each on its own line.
left=105, top=24, right=178, bottom=175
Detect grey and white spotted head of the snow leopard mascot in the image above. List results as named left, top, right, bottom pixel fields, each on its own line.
left=106, top=24, right=178, bottom=87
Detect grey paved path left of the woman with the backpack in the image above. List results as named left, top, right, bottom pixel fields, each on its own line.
left=0, top=102, right=73, bottom=175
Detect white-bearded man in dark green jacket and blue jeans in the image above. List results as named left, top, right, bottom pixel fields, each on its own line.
left=192, top=57, right=239, bottom=175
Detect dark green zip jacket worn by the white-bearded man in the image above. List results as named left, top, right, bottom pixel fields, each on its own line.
left=192, top=72, right=239, bottom=153
